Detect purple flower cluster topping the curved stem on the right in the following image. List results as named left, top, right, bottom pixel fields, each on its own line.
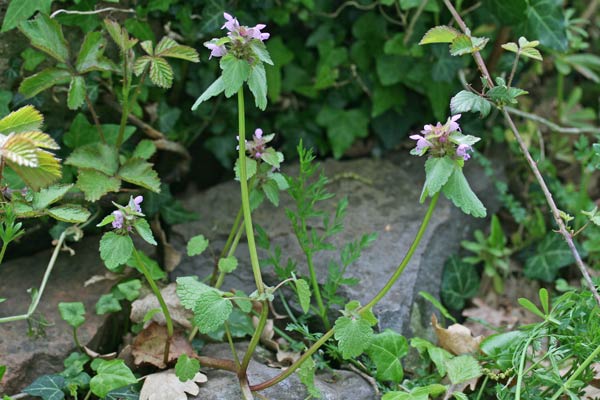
left=410, top=114, right=478, bottom=161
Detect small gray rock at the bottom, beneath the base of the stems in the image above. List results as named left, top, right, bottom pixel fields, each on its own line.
left=190, top=343, right=378, bottom=400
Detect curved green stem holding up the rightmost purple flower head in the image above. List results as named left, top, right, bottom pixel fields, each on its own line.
left=250, top=192, right=440, bottom=391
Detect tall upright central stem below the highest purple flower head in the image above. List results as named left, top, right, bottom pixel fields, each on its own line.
left=238, top=86, right=269, bottom=387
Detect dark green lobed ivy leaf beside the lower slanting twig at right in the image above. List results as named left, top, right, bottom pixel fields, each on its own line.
left=523, top=233, right=585, bottom=282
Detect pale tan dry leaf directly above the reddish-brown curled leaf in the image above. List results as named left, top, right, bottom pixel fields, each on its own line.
left=130, top=282, right=193, bottom=329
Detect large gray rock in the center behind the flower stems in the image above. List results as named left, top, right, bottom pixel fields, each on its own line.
left=174, top=156, right=497, bottom=335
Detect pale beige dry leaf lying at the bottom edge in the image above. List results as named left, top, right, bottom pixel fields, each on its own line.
left=140, top=369, right=208, bottom=400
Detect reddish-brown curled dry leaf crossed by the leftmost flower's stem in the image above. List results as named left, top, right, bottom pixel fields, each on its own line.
left=131, top=322, right=194, bottom=368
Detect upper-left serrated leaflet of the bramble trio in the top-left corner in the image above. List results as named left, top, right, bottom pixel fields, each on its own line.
left=19, top=13, right=69, bottom=63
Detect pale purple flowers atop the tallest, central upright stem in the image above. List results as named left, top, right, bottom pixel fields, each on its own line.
left=204, top=13, right=271, bottom=60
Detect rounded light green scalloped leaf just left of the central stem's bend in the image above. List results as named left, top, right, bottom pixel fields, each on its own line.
left=192, top=290, right=233, bottom=333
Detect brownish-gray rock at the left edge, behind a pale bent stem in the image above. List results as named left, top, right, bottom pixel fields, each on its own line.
left=0, top=237, right=114, bottom=394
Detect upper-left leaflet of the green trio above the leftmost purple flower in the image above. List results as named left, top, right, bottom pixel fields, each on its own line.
left=65, top=143, right=119, bottom=176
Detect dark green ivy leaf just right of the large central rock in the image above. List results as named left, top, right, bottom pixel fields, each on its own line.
left=440, top=256, right=480, bottom=310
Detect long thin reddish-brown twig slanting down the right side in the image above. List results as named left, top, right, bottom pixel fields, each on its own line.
left=444, top=0, right=600, bottom=305
